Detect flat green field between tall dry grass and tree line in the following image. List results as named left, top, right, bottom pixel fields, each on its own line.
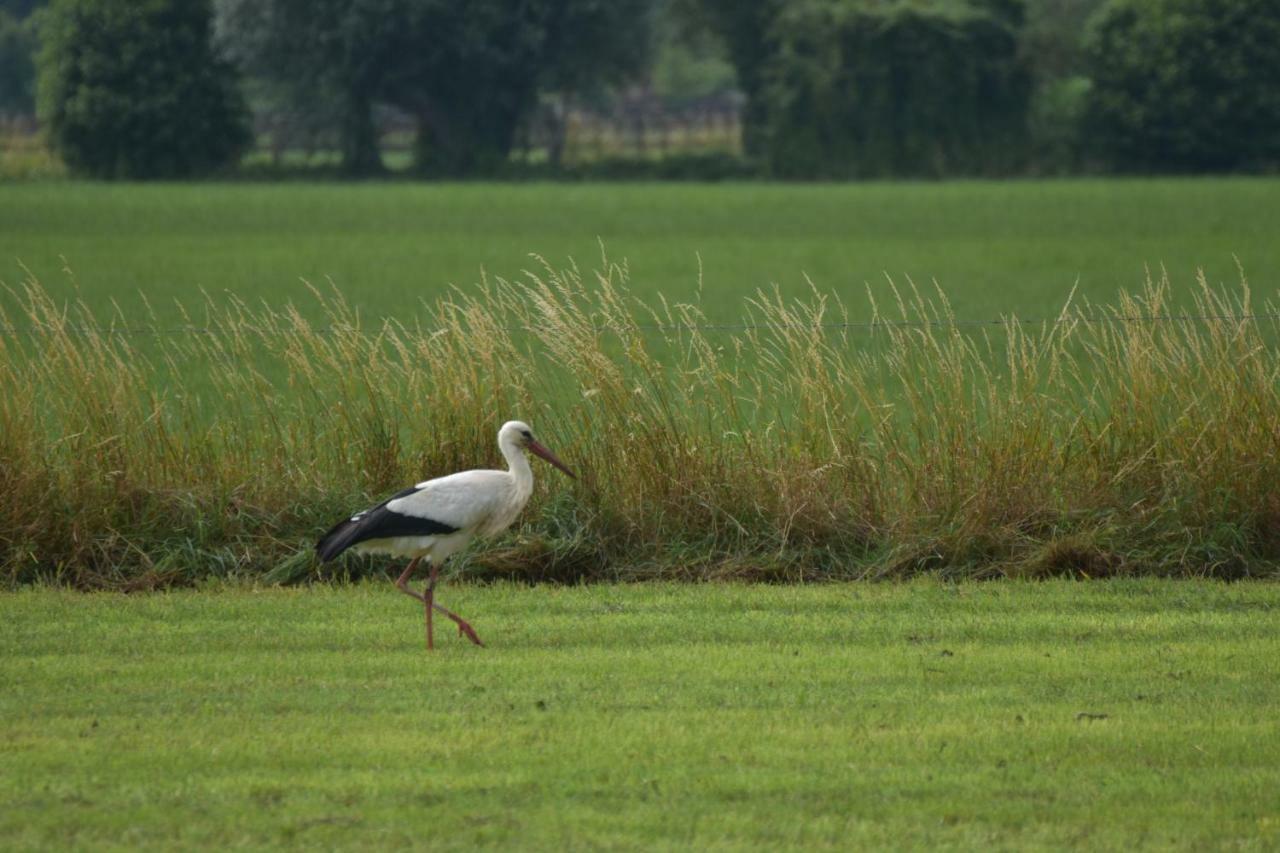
left=0, top=178, right=1280, bottom=323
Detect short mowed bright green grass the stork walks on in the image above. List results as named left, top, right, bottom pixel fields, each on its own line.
left=0, top=580, right=1280, bottom=850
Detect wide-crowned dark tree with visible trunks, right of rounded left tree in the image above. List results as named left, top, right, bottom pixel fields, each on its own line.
left=219, top=0, right=649, bottom=174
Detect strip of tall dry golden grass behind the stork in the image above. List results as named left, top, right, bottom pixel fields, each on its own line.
left=0, top=261, right=1280, bottom=588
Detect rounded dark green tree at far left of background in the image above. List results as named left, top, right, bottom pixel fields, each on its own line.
left=37, top=0, right=250, bottom=178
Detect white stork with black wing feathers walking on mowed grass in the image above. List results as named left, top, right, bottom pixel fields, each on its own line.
left=316, top=420, right=573, bottom=649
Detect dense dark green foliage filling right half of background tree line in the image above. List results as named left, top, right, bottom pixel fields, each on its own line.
left=676, top=0, right=1280, bottom=177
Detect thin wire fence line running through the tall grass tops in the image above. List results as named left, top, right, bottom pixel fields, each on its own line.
left=0, top=313, right=1280, bottom=337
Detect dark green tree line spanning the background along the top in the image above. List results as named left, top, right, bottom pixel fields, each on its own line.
left=0, top=0, right=1280, bottom=179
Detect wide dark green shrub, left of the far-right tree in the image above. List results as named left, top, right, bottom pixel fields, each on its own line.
left=765, top=0, right=1029, bottom=178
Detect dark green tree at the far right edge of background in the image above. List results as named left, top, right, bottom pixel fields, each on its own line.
left=1085, top=0, right=1280, bottom=172
